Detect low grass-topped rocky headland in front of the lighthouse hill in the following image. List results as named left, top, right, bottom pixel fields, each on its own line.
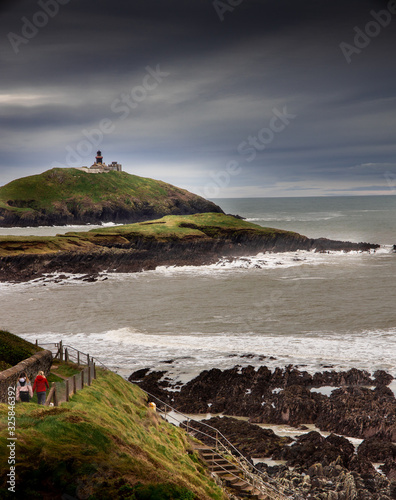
left=0, top=213, right=380, bottom=282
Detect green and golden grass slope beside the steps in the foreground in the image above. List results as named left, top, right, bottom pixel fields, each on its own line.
left=0, top=370, right=224, bottom=500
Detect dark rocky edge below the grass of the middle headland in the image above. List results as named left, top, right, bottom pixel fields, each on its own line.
left=0, top=230, right=380, bottom=282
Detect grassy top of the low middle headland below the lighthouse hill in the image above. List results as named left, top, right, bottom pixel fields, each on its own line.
left=0, top=213, right=304, bottom=257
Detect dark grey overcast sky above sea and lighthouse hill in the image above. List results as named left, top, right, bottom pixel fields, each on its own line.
left=0, top=0, right=396, bottom=198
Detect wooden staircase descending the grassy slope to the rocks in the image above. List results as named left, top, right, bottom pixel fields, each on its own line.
left=194, top=444, right=276, bottom=500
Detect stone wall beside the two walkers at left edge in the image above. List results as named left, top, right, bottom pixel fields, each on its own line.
left=0, top=351, right=52, bottom=403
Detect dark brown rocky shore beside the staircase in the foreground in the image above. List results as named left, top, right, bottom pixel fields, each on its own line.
left=129, top=366, right=396, bottom=500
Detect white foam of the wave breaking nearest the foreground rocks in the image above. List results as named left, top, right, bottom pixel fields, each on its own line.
left=23, top=328, right=396, bottom=382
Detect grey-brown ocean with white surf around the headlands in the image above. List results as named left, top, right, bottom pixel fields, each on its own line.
left=0, top=195, right=396, bottom=390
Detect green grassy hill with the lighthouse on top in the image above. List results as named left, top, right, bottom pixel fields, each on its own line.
left=0, top=168, right=222, bottom=227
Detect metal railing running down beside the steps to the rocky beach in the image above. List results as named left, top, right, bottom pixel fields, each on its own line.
left=144, top=391, right=304, bottom=500
